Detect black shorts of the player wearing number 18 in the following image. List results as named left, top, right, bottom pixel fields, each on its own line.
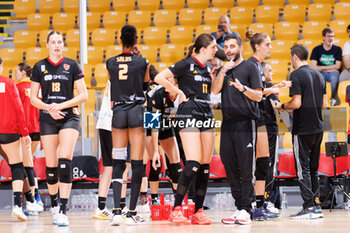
left=40, top=118, right=80, bottom=136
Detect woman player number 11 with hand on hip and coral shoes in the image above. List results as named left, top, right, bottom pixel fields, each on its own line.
left=155, top=34, right=217, bottom=224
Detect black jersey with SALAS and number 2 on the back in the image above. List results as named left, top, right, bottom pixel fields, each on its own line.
left=106, top=53, right=148, bottom=106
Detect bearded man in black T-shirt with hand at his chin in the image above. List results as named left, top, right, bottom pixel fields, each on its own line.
left=212, top=35, right=263, bottom=224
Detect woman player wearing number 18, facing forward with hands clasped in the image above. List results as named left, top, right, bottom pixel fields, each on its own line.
left=30, top=31, right=88, bottom=226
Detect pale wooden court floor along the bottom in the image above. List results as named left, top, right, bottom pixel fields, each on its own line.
left=0, top=210, right=350, bottom=233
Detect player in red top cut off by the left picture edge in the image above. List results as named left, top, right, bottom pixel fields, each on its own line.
left=0, top=58, right=31, bottom=221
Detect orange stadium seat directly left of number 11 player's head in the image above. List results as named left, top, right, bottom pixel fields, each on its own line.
left=159, top=44, right=185, bottom=63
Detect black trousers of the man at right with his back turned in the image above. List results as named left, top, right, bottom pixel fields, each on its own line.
left=293, top=132, right=323, bottom=208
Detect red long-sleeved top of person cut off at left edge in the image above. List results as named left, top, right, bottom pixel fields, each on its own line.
left=0, top=75, right=29, bottom=137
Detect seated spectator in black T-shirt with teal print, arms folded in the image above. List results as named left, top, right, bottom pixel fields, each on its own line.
left=310, top=27, right=342, bottom=106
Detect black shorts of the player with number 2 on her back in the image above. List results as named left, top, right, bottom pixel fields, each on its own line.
left=112, top=104, right=145, bottom=129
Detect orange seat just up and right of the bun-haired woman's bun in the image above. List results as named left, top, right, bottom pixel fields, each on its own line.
left=274, top=22, right=299, bottom=40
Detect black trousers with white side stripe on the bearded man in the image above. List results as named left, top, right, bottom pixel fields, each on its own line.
left=220, top=119, right=256, bottom=213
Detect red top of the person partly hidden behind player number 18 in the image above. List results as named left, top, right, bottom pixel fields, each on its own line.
left=16, top=78, right=40, bottom=133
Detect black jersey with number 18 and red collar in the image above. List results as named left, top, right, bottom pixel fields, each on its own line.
left=31, top=57, right=84, bottom=123
